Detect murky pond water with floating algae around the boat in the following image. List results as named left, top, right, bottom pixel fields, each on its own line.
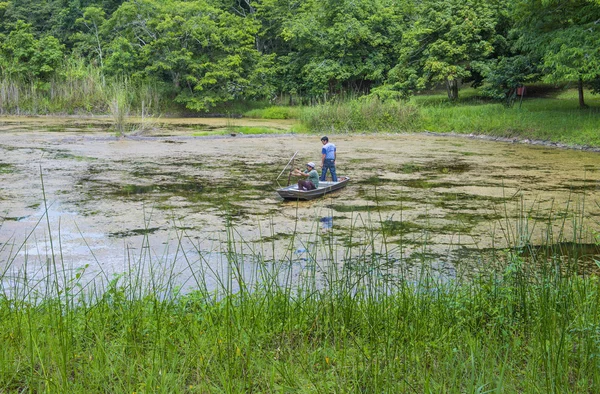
left=0, top=119, right=600, bottom=294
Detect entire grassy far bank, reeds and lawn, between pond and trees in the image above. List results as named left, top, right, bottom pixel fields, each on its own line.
left=248, top=86, right=600, bottom=147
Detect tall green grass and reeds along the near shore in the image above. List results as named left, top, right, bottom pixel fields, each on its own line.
left=0, top=195, right=600, bottom=393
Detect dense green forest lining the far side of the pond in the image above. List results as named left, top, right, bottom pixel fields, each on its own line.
left=0, top=0, right=600, bottom=112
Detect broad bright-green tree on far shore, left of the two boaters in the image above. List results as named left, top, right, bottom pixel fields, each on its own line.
left=106, top=0, right=270, bottom=111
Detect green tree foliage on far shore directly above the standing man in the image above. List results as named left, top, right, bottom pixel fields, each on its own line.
left=281, top=0, right=404, bottom=96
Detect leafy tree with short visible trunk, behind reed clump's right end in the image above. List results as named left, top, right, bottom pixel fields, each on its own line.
left=388, top=0, right=506, bottom=100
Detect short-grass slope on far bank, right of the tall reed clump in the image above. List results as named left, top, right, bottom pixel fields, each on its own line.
left=412, top=89, right=600, bottom=146
